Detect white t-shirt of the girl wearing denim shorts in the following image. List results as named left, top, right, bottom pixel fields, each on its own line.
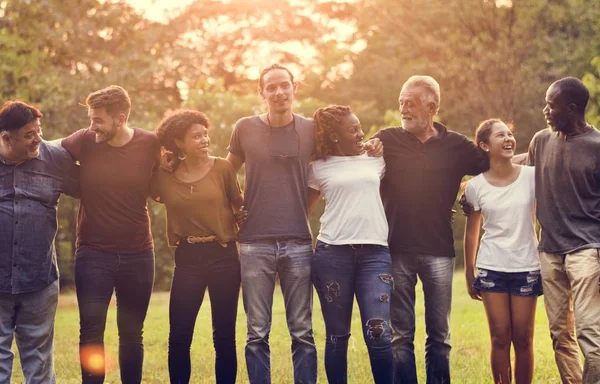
left=465, top=166, right=540, bottom=272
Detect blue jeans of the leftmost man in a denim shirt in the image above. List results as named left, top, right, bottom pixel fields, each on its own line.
left=0, top=280, right=58, bottom=384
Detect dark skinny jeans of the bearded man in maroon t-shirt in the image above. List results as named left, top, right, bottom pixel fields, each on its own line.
left=75, top=247, right=154, bottom=384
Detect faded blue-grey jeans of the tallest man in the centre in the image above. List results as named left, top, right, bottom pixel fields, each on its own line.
left=240, top=240, right=317, bottom=384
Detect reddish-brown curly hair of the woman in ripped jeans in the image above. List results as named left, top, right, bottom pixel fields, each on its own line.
left=313, top=105, right=352, bottom=160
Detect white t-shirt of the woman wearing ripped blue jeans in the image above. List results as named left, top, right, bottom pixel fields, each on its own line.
left=308, top=154, right=388, bottom=246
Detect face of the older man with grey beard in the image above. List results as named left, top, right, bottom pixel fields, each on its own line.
left=398, top=85, right=435, bottom=133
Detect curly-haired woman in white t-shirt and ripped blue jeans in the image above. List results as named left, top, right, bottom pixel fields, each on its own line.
left=308, top=105, right=393, bottom=384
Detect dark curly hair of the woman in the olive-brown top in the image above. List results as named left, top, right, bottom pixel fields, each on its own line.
left=156, top=109, right=210, bottom=156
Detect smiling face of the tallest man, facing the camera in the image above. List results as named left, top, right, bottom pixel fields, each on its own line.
left=260, top=68, right=296, bottom=114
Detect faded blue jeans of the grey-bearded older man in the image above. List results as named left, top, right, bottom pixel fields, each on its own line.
left=390, top=254, right=454, bottom=384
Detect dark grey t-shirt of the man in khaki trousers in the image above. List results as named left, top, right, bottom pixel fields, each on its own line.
left=527, top=127, right=600, bottom=254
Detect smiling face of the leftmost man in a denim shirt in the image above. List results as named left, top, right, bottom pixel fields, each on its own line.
left=2, top=119, right=42, bottom=162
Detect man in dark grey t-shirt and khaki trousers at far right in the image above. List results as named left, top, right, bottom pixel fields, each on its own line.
left=527, top=77, right=600, bottom=384
